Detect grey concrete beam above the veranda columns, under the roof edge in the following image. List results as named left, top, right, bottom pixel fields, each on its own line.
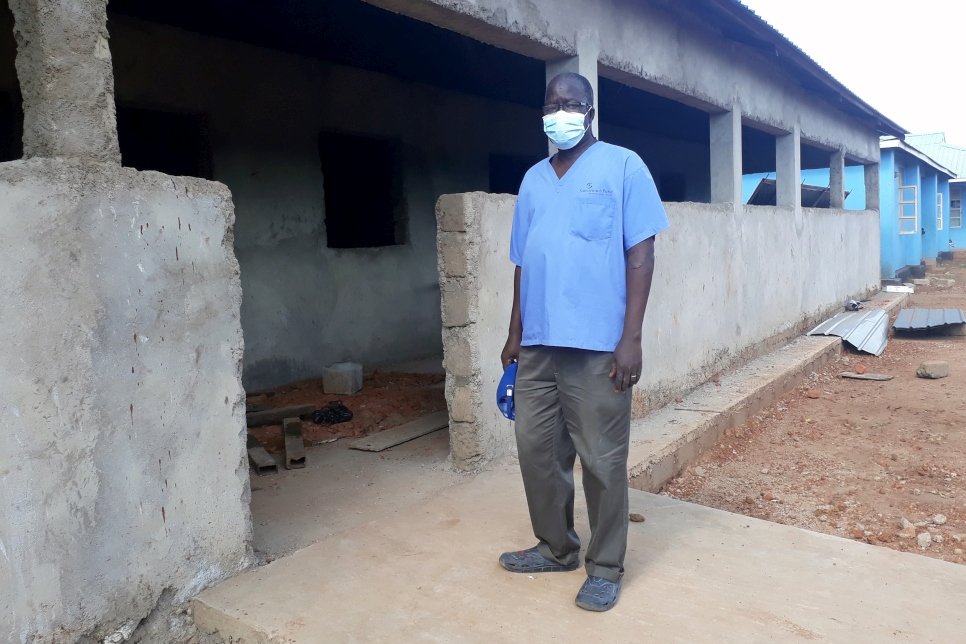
left=367, top=0, right=879, bottom=162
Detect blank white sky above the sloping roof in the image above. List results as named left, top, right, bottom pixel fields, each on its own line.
left=742, top=0, right=966, bottom=146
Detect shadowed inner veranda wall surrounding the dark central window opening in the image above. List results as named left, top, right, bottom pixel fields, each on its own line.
left=110, top=17, right=546, bottom=388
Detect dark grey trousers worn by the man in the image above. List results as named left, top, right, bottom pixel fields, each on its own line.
left=513, top=346, right=631, bottom=581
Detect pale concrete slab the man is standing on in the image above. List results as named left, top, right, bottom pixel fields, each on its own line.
left=194, top=466, right=966, bottom=643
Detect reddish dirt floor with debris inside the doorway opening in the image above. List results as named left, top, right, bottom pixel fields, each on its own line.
left=248, top=371, right=446, bottom=454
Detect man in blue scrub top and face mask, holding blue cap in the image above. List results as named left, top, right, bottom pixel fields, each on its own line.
left=500, top=73, right=668, bottom=611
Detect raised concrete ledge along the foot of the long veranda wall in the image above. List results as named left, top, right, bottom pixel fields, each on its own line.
left=628, top=293, right=908, bottom=492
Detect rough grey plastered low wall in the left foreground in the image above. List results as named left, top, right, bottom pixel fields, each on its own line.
left=0, top=160, right=251, bottom=642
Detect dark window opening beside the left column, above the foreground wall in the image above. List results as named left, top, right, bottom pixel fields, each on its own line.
left=117, top=105, right=213, bottom=179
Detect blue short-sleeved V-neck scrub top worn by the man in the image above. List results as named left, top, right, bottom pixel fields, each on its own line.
left=510, top=141, right=668, bottom=351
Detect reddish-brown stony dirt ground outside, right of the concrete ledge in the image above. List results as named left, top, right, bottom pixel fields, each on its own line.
left=663, top=255, right=966, bottom=564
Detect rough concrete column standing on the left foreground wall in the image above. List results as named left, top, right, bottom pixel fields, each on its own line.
left=9, top=0, right=121, bottom=164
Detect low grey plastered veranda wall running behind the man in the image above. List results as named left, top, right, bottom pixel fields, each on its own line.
left=437, top=193, right=879, bottom=469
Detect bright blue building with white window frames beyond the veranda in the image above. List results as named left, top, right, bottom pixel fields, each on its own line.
left=742, top=137, right=966, bottom=278
